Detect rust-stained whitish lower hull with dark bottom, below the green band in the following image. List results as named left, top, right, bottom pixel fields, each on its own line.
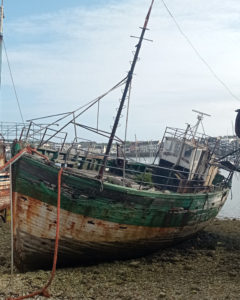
left=13, top=193, right=218, bottom=270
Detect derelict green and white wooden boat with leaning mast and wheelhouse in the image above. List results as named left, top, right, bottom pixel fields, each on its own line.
left=12, top=1, right=232, bottom=270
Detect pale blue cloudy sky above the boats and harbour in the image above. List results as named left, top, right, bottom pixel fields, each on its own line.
left=0, top=0, right=240, bottom=140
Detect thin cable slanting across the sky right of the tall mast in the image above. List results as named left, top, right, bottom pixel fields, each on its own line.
left=161, top=0, right=240, bottom=101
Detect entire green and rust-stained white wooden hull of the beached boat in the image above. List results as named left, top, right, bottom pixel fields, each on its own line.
left=13, top=155, right=228, bottom=270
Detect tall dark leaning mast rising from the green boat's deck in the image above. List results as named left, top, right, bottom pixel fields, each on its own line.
left=98, top=0, right=154, bottom=179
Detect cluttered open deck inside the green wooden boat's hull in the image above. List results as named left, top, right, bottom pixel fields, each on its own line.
left=32, top=151, right=229, bottom=193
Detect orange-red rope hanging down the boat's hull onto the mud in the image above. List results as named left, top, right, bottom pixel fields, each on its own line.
left=6, top=168, right=63, bottom=300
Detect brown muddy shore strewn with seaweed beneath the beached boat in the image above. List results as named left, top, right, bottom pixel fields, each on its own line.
left=0, top=220, right=240, bottom=300
